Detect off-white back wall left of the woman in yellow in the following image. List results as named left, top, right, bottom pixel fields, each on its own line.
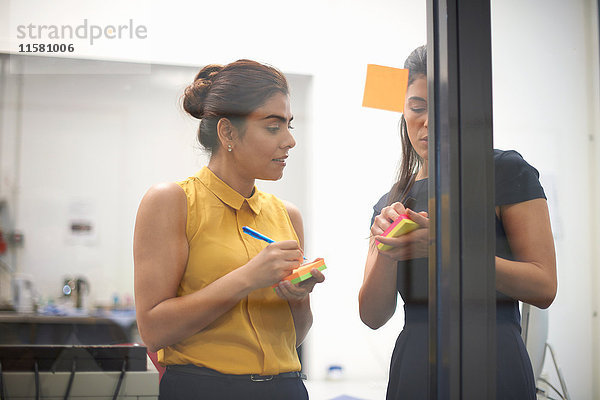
left=2, top=58, right=203, bottom=305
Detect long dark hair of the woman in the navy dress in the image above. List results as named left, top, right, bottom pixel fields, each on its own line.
left=387, top=46, right=427, bottom=205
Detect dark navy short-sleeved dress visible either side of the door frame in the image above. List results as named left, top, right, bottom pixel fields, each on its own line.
left=371, top=150, right=546, bottom=400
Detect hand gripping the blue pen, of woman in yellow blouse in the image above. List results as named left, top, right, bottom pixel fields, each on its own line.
left=245, top=240, right=303, bottom=289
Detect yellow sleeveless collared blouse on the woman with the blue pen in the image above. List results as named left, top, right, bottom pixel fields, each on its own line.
left=158, top=167, right=300, bottom=375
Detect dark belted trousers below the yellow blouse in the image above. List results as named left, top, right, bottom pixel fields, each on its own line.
left=159, top=369, right=308, bottom=400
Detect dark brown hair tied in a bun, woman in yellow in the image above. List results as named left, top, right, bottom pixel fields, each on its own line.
left=183, top=60, right=289, bottom=153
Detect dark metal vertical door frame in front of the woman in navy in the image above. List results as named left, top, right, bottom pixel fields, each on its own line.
left=427, top=0, right=496, bottom=399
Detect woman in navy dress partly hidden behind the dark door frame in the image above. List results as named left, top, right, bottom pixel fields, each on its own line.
left=359, top=46, right=557, bottom=400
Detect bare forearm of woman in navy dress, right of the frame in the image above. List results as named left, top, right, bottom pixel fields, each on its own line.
left=496, top=257, right=556, bottom=308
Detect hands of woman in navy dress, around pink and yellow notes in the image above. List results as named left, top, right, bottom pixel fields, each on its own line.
left=371, top=203, right=429, bottom=261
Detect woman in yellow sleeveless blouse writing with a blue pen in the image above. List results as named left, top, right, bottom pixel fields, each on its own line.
left=134, top=60, right=324, bottom=399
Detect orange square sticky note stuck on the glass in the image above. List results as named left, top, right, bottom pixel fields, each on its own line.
left=363, top=64, right=408, bottom=112
